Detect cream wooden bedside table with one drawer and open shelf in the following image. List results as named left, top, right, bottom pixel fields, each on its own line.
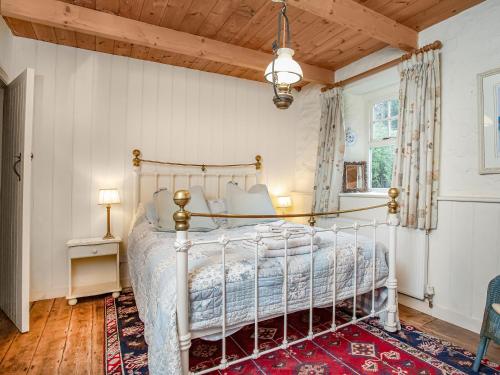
left=66, top=237, right=122, bottom=305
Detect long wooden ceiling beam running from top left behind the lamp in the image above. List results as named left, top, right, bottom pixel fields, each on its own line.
left=0, top=0, right=334, bottom=83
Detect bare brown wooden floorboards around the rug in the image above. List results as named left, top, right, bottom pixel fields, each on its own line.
left=0, top=297, right=500, bottom=375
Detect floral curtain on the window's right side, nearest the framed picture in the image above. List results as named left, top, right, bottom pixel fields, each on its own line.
left=392, top=50, right=441, bottom=230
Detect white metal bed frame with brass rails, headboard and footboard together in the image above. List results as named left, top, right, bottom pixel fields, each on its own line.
left=133, top=150, right=399, bottom=375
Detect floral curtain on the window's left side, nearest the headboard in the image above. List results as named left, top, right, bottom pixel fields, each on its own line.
left=313, top=87, right=345, bottom=212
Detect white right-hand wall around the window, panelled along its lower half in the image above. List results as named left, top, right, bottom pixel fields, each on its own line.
left=336, top=0, right=500, bottom=331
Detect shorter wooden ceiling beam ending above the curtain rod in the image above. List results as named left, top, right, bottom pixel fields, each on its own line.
left=288, top=0, right=418, bottom=51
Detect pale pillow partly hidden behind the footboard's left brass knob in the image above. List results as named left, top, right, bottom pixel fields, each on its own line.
left=154, top=186, right=217, bottom=232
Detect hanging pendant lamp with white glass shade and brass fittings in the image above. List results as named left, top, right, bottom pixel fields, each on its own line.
left=264, top=0, right=303, bottom=109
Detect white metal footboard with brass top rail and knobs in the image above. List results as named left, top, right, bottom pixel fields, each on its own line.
left=174, top=188, right=399, bottom=374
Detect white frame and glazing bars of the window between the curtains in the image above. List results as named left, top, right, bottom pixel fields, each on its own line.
left=366, top=90, right=400, bottom=193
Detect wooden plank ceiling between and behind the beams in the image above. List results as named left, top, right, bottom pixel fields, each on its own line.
left=1, top=0, right=483, bottom=86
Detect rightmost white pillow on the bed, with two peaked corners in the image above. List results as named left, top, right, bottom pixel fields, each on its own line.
left=226, top=182, right=276, bottom=227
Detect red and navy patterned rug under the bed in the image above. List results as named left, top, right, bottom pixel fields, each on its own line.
left=105, top=290, right=500, bottom=375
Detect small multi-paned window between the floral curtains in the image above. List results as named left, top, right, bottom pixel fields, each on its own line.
left=369, top=97, right=399, bottom=190
